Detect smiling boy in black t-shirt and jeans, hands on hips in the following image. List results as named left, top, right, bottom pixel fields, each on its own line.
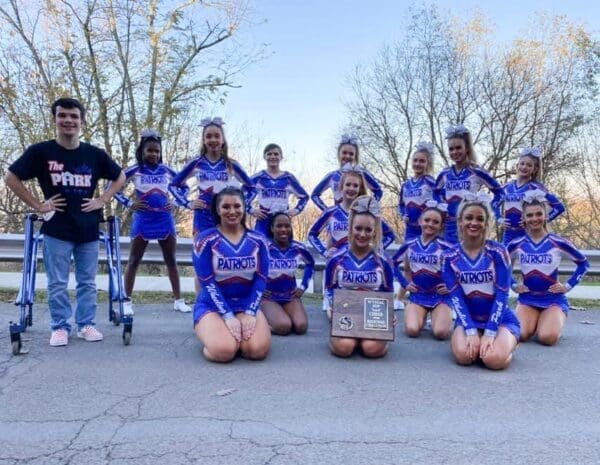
left=5, top=98, right=125, bottom=346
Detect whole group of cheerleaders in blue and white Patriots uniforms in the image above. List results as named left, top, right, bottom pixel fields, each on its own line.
left=116, top=118, right=589, bottom=369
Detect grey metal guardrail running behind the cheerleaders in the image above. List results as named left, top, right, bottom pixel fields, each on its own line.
left=0, top=234, right=600, bottom=293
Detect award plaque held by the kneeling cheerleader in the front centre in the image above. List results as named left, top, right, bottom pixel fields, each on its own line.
left=331, top=289, right=394, bottom=341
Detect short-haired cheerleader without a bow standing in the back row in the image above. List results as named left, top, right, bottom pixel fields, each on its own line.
left=251, top=144, right=308, bottom=235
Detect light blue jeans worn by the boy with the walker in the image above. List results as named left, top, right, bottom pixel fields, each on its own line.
left=44, top=235, right=98, bottom=331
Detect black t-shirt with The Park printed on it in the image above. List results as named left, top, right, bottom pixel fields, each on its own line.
left=8, top=140, right=121, bottom=243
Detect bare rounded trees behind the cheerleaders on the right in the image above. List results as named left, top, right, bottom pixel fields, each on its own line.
left=347, top=7, right=598, bottom=208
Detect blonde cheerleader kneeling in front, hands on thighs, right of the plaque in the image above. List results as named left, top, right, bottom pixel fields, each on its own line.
left=442, top=194, right=520, bottom=370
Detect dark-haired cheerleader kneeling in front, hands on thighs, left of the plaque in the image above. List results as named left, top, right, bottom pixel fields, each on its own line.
left=193, top=187, right=271, bottom=362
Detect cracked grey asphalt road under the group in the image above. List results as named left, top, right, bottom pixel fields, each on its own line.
left=0, top=303, right=600, bottom=465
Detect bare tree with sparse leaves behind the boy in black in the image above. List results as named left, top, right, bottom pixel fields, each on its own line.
left=0, top=0, right=262, bottom=231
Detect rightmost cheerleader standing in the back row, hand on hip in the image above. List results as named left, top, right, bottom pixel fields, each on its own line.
left=496, top=147, right=565, bottom=246
